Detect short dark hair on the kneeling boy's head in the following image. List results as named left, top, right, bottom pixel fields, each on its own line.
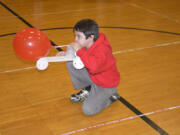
left=73, top=19, right=99, bottom=41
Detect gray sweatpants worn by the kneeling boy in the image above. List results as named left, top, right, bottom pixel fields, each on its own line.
left=67, top=62, right=117, bottom=115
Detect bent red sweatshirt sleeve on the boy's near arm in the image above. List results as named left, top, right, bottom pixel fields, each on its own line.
left=77, top=48, right=106, bottom=74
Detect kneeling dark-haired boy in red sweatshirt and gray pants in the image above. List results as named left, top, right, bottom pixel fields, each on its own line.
left=59, top=19, right=120, bottom=115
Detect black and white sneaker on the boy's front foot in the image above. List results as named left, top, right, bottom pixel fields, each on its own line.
left=70, top=89, right=89, bottom=103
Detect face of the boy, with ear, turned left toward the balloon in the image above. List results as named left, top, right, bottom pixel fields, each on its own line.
left=74, top=31, right=94, bottom=48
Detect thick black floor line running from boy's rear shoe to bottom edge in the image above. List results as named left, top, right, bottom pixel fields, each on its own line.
left=119, top=97, right=168, bottom=135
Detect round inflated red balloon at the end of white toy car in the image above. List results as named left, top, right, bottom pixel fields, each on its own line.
left=13, top=28, right=52, bottom=61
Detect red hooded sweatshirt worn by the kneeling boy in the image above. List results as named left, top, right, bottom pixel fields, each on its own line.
left=77, top=33, right=120, bottom=88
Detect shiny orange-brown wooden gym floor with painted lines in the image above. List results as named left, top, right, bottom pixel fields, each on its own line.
left=0, top=0, right=180, bottom=135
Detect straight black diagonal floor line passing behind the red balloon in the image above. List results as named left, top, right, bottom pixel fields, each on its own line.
left=0, top=1, right=62, bottom=51
